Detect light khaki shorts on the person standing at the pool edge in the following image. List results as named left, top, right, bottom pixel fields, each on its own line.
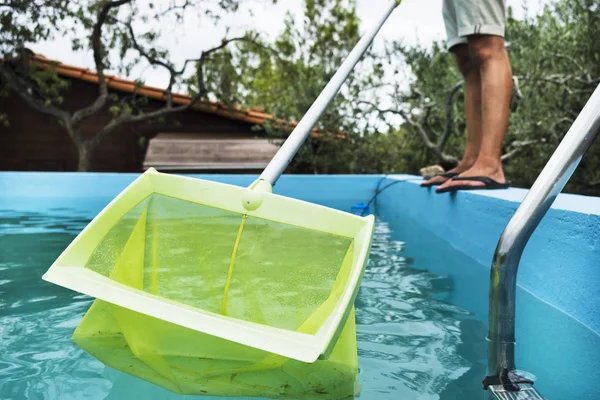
left=443, top=0, right=506, bottom=49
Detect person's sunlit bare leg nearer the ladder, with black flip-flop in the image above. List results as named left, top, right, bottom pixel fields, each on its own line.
left=438, top=35, right=512, bottom=190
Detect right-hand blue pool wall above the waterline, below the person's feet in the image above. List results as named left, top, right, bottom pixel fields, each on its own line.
left=377, top=175, right=600, bottom=333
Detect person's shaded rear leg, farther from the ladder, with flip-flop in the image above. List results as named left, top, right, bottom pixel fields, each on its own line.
left=421, top=44, right=482, bottom=186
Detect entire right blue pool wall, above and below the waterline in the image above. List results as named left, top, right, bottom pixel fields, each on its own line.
left=375, top=177, right=600, bottom=400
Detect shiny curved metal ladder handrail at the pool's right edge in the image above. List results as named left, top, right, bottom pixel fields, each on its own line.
left=483, top=86, right=600, bottom=400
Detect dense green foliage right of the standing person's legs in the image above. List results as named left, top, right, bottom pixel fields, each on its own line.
left=506, top=0, right=600, bottom=195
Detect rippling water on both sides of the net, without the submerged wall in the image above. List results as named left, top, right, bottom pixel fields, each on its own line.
left=0, top=210, right=480, bottom=400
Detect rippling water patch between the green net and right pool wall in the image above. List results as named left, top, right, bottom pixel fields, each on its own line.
left=356, top=220, right=472, bottom=399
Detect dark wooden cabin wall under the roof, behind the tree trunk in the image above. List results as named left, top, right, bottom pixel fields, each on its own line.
left=0, top=80, right=264, bottom=172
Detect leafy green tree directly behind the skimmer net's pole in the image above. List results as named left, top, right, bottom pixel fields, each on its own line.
left=199, top=0, right=383, bottom=173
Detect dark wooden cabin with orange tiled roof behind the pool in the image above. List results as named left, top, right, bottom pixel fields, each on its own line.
left=0, top=55, right=296, bottom=173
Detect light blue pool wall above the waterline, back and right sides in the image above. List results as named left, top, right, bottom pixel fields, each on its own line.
left=0, top=172, right=600, bottom=333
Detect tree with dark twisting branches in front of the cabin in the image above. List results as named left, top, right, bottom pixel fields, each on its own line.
left=0, top=0, right=275, bottom=171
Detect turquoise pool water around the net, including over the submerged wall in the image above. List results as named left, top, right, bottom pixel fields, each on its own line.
left=0, top=205, right=600, bottom=400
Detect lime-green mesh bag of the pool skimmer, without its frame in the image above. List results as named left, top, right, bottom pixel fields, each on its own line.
left=73, top=193, right=357, bottom=399
